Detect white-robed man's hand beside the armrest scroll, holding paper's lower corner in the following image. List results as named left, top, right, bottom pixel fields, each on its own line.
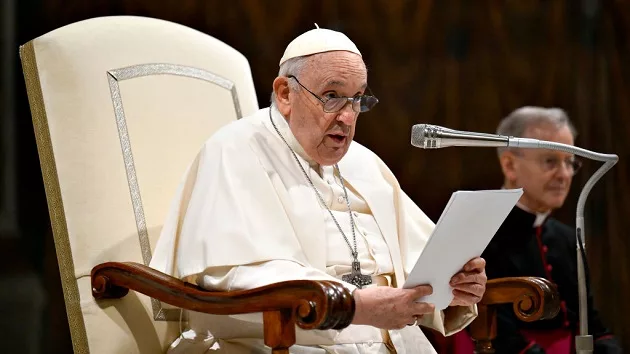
left=352, top=285, right=435, bottom=329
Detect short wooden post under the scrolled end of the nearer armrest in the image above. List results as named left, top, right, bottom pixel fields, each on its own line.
left=263, top=310, right=295, bottom=354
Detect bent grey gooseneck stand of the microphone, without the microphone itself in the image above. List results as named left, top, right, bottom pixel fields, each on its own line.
left=508, top=137, right=619, bottom=354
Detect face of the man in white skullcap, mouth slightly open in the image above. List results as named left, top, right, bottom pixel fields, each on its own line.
left=274, top=51, right=367, bottom=165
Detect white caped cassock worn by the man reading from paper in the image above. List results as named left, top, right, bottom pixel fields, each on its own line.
left=150, top=108, right=477, bottom=354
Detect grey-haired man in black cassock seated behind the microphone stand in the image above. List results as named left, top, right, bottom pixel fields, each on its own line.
left=483, top=107, right=621, bottom=354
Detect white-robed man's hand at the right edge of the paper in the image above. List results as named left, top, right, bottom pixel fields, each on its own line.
left=450, top=257, right=488, bottom=306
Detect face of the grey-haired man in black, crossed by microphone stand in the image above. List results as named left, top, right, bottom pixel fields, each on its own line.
left=500, top=124, right=574, bottom=212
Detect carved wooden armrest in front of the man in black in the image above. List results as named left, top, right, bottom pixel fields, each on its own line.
left=470, top=277, right=560, bottom=353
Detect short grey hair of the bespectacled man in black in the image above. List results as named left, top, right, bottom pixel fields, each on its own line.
left=497, top=106, right=577, bottom=155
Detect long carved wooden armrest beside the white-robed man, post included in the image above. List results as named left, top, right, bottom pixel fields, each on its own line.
left=92, top=262, right=355, bottom=353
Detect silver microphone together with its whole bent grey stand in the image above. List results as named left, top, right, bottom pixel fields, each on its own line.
left=411, top=124, right=619, bottom=354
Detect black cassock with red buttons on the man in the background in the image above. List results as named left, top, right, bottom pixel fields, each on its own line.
left=482, top=207, right=622, bottom=354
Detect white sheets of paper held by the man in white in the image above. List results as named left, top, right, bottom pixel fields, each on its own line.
left=403, top=188, right=523, bottom=310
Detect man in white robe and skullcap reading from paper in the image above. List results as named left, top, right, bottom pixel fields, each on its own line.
left=151, top=28, right=486, bottom=354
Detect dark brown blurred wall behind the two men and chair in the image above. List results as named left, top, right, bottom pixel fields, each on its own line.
left=0, top=0, right=630, bottom=353
